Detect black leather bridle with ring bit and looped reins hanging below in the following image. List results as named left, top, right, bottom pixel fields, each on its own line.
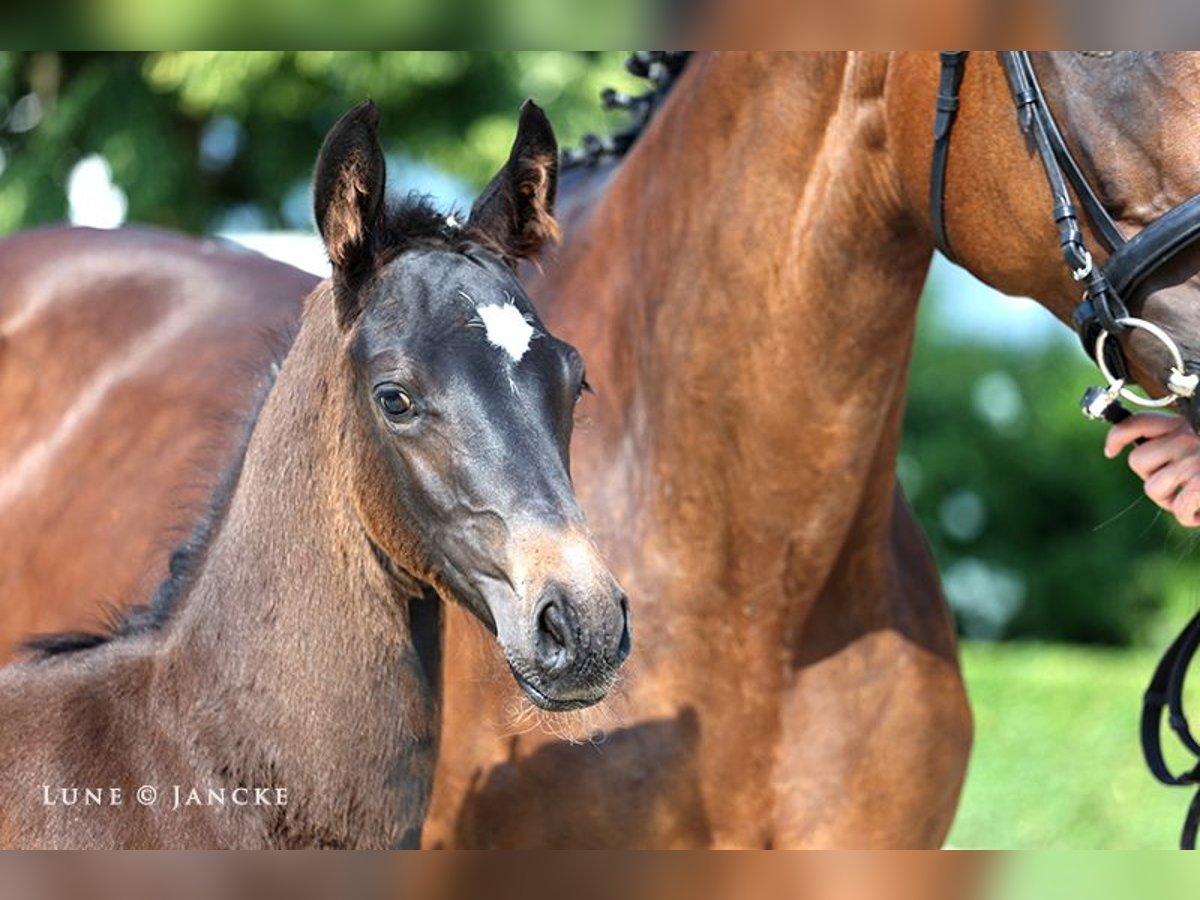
left=930, top=50, right=1200, bottom=850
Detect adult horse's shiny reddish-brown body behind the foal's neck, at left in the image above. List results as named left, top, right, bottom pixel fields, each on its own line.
left=0, top=228, right=317, bottom=662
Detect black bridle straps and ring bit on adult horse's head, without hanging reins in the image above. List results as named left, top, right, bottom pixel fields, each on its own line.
left=930, top=50, right=1200, bottom=421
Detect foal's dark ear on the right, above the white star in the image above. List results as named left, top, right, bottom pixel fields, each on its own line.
left=468, top=100, right=559, bottom=264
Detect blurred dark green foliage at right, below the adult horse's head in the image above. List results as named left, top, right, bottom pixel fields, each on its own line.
left=899, top=298, right=1200, bottom=646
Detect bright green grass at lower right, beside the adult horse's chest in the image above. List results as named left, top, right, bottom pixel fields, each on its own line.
left=948, top=643, right=1200, bottom=848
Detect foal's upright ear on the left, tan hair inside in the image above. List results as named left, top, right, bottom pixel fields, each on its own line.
left=312, top=100, right=386, bottom=312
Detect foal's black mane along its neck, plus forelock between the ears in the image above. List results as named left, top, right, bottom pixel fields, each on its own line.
left=18, top=199, right=468, bottom=660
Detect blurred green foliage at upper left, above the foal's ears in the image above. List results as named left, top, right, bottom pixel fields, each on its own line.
left=0, top=50, right=638, bottom=233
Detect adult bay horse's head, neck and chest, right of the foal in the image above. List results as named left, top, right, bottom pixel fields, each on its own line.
left=0, top=53, right=1200, bottom=847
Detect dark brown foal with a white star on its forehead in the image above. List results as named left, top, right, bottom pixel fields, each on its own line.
left=0, top=102, right=629, bottom=847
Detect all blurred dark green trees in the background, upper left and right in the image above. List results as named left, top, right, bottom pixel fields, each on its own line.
left=0, top=50, right=1200, bottom=646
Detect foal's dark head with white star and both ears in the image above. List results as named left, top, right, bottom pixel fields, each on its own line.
left=314, top=102, right=630, bottom=709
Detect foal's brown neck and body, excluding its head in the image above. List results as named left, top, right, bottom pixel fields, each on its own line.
left=0, top=278, right=438, bottom=847
